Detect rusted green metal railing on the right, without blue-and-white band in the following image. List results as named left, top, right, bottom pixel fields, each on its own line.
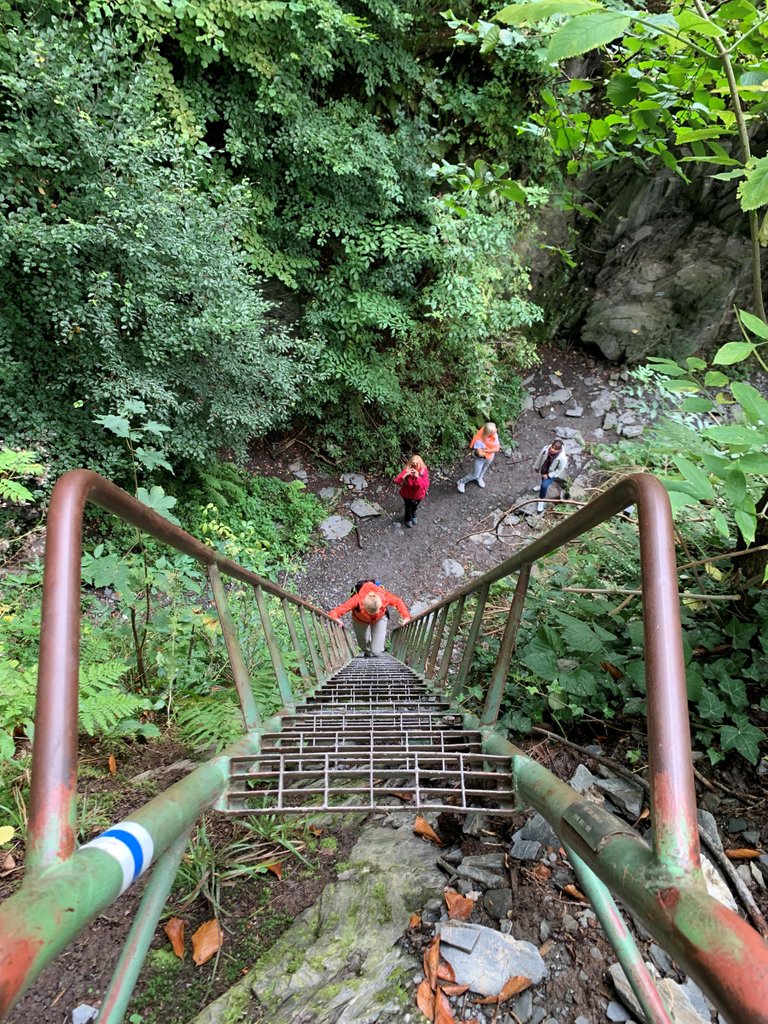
left=392, top=474, right=768, bottom=1024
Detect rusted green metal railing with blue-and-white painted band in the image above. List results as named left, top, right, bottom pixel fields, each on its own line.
left=0, top=469, right=352, bottom=1024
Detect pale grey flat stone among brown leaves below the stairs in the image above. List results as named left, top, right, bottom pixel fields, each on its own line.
left=435, top=922, right=547, bottom=995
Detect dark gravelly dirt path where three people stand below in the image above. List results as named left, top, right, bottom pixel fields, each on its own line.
left=280, top=349, right=634, bottom=610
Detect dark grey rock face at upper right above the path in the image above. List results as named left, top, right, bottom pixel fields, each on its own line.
left=534, top=162, right=751, bottom=362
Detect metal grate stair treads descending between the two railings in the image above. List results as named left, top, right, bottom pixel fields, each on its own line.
left=226, top=654, right=514, bottom=815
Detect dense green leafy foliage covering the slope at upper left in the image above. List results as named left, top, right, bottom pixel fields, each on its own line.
left=0, top=0, right=542, bottom=476
